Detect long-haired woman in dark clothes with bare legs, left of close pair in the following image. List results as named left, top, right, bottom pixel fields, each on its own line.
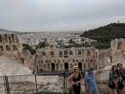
left=108, top=65, right=119, bottom=94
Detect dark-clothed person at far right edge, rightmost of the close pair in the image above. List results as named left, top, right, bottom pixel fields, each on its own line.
left=117, top=63, right=125, bottom=94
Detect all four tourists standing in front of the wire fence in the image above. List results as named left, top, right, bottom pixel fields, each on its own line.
left=67, top=63, right=125, bottom=94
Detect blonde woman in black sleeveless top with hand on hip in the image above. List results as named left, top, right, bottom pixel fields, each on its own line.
left=67, top=65, right=83, bottom=94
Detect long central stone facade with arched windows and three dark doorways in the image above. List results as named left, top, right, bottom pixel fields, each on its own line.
left=35, top=47, right=97, bottom=71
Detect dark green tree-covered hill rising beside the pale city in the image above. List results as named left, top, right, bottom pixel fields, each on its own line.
left=81, top=23, right=125, bottom=49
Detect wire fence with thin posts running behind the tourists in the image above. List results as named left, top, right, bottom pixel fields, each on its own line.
left=0, top=71, right=125, bottom=94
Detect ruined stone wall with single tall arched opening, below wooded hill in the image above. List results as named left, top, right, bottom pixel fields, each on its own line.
left=111, top=38, right=125, bottom=63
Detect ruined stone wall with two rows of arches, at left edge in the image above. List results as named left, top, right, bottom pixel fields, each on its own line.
left=0, top=32, right=21, bottom=56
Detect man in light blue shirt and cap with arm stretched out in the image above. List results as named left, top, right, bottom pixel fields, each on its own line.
left=85, top=68, right=101, bottom=94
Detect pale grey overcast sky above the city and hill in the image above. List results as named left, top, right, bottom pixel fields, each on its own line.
left=0, top=0, right=125, bottom=32
